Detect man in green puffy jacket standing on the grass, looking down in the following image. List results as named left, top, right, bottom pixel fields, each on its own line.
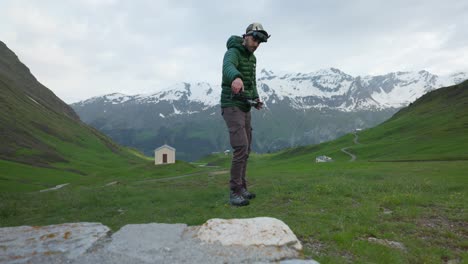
left=221, top=23, right=270, bottom=206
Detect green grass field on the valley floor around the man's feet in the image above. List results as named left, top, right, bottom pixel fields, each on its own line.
left=0, top=147, right=468, bottom=263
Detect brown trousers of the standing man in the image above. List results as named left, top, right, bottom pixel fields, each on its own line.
left=221, top=107, right=252, bottom=192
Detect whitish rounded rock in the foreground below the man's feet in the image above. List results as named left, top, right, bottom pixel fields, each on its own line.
left=197, top=217, right=302, bottom=251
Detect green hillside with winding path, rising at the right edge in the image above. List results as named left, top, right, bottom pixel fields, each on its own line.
left=274, top=80, right=468, bottom=161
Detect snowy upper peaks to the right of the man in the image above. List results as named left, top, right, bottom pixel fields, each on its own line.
left=259, top=68, right=468, bottom=111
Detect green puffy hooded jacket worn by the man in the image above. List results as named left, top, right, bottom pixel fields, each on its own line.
left=221, top=36, right=258, bottom=112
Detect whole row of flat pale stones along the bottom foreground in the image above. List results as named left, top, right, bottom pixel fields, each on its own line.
left=0, top=217, right=316, bottom=264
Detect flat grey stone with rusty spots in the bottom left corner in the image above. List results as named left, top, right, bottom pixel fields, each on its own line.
left=0, top=223, right=110, bottom=263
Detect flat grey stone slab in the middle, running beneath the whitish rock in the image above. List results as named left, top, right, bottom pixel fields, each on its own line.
left=104, top=223, right=306, bottom=264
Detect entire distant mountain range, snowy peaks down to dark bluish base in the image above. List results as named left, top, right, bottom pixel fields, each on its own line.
left=71, top=68, right=468, bottom=160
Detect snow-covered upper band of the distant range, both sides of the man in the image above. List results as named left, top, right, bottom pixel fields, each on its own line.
left=74, top=68, right=468, bottom=114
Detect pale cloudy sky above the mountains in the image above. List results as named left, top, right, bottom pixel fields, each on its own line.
left=0, top=0, right=468, bottom=103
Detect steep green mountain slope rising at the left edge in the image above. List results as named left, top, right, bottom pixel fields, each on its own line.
left=0, top=41, right=143, bottom=170
